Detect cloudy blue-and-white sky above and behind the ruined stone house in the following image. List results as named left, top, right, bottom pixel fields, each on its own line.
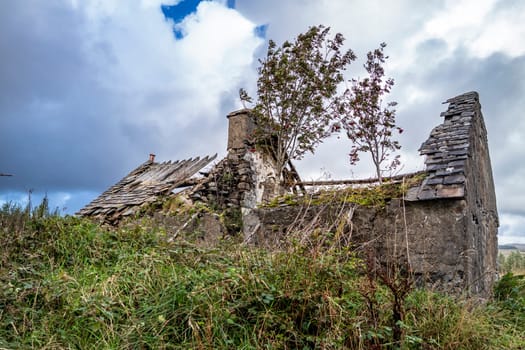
left=0, top=0, right=525, bottom=243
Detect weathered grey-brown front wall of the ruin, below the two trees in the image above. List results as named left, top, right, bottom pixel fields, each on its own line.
left=251, top=199, right=476, bottom=294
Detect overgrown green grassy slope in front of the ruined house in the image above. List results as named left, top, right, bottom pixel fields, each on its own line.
left=0, top=203, right=525, bottom=350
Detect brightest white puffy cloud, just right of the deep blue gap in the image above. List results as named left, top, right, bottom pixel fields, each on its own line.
left=171, top=2, right=263, bottom=121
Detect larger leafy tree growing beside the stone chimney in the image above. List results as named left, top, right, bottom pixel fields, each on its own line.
left=239, top=25, right=356, bottom=180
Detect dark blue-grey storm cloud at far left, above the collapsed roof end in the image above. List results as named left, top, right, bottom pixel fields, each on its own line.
left=0, top=1, right=150, bottom=191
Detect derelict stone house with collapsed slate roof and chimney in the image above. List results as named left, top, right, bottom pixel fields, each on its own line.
left=79, top=92, right=498, bottom=296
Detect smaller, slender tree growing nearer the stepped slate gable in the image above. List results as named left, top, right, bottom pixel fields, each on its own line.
left=341, top=43, right=403, bottom=184
